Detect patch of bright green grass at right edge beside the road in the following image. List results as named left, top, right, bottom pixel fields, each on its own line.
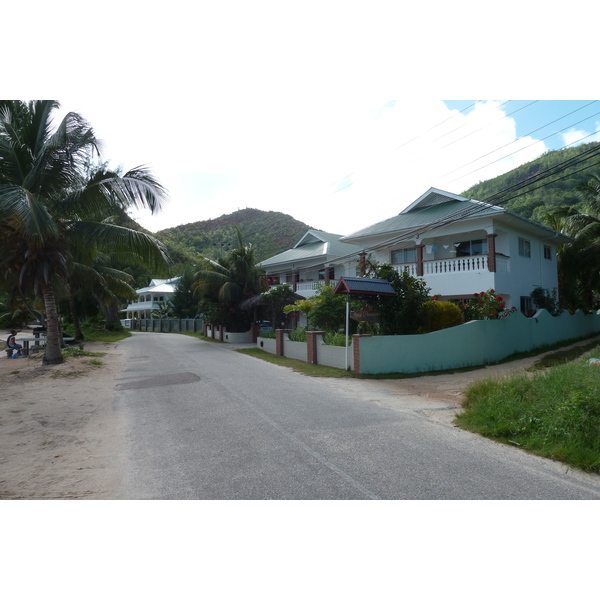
left=456, top=342, right=600, bottom=472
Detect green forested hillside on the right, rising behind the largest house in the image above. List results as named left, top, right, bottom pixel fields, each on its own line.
left=462, top=142, right=600, bottom=220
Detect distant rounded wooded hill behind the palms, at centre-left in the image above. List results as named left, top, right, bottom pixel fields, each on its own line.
left=156, top=208, right=311, bottom=261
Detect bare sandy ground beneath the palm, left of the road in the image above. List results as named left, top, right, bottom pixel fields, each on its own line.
left=0, top=342, right=125, bottom=499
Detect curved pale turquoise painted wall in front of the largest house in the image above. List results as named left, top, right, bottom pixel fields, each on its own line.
left=360, top=310, right=600, bottom=374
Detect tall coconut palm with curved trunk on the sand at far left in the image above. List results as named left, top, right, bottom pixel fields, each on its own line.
left=0, top=100, right=167, bottom=364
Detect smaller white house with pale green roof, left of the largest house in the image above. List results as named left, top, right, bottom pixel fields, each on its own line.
left=260, top=229, right=358, bottom=298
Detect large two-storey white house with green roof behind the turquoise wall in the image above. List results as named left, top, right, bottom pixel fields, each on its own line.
left=339, top=188, right=572, bottom=314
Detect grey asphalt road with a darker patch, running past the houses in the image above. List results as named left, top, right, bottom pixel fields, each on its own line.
left=115, top=333, right=600, bottom=499
